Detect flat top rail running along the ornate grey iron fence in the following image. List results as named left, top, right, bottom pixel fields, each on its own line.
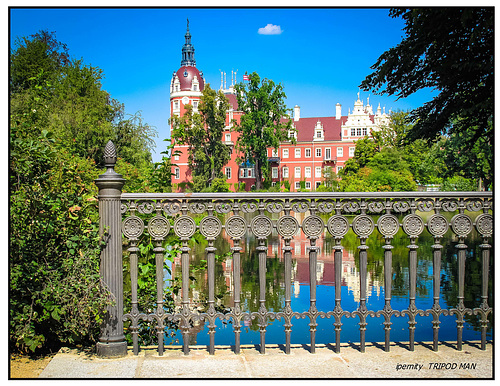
left=121, top=191, right=493, bottom=200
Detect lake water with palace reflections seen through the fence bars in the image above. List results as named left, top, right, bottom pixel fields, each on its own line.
left=161, top=214, right=493, bottom=345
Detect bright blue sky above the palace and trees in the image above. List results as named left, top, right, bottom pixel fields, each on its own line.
left=10, top=8, right=438, bottom=161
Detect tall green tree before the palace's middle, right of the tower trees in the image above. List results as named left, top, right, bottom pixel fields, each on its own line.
left=235, top=72, right=293, bottom=190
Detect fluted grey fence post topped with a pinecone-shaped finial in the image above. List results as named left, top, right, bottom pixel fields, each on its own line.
left=95, top=141, right=127, bottom=357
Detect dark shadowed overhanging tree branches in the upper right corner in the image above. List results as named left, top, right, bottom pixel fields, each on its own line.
left=361, top=7, right=494, bottom=146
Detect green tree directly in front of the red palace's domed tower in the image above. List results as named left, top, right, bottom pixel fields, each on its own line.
left=170, top=84, right=231, bottom=191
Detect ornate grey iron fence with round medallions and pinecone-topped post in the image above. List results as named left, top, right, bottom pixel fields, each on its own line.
left=96, top=144, right=493, bottom=356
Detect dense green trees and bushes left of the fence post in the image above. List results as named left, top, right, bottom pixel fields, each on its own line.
left=9, top=33, right=160, bottom=352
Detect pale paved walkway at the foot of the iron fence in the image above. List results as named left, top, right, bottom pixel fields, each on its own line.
left=40, top=342, right=493, bottom=379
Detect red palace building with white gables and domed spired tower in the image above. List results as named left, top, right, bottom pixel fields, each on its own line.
left=170, top=21, right=390, bottom=191
